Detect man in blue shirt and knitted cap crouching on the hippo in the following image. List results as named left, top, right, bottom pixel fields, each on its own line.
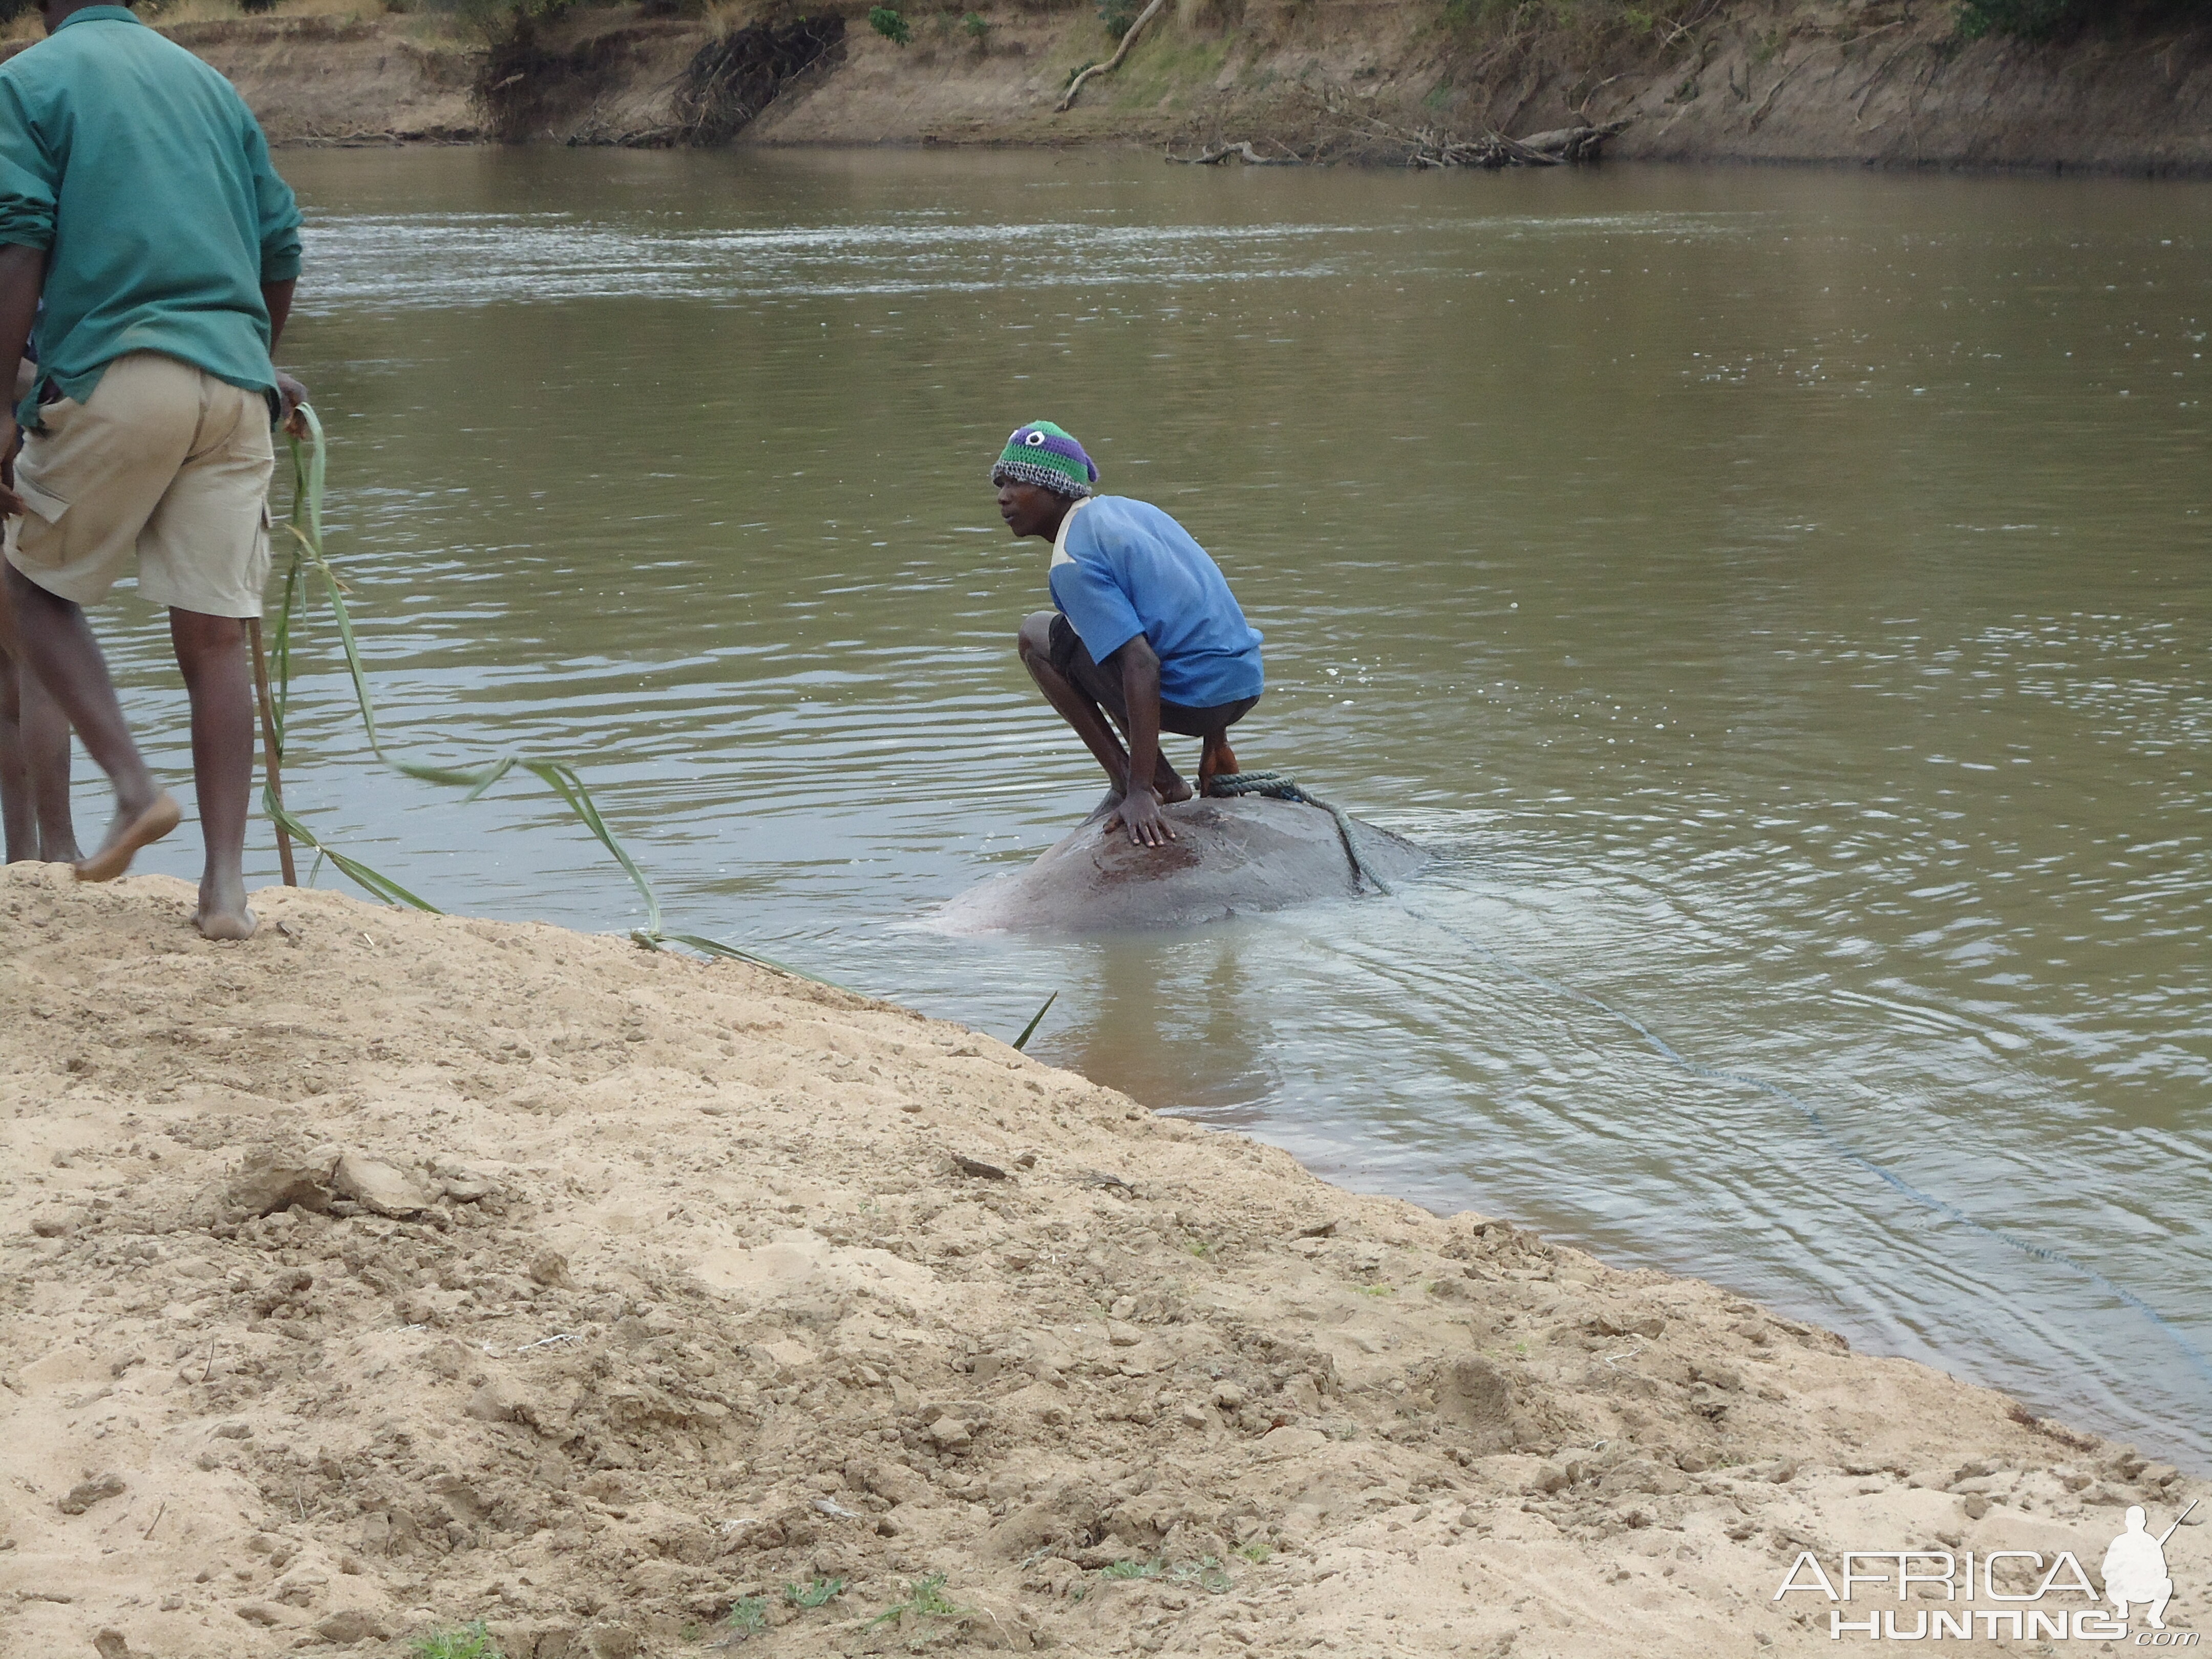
left=991, top=420, right=1265, bottom=847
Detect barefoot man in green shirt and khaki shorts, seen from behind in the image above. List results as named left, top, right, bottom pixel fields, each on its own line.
left=0, top=0, right=299, bottom=938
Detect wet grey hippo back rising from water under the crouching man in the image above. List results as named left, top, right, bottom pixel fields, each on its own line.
left=935, top=796, right=1427, bottom=933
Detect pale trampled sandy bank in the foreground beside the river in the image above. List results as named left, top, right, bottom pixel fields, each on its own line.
left=0, top=867, right=2212, bottom=1659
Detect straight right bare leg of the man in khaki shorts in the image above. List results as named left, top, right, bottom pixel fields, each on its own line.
left=168, top=608, right=259, bottom=938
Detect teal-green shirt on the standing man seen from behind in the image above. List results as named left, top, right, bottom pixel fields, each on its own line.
left=0, top=7, right=299, bottom=427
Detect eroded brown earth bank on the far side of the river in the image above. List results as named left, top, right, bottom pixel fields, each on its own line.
left=30, top=0, right=2212, bottom=177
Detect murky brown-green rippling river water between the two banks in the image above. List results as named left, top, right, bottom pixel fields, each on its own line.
left=80, top=148, right=2212, bottom=1469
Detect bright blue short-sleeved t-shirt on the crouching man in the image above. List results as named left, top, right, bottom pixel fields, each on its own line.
left=1051, top=496, right=1265, bottom=708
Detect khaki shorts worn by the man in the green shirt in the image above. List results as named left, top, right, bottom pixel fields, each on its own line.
left=7, top=352, right=276, bottom=617
